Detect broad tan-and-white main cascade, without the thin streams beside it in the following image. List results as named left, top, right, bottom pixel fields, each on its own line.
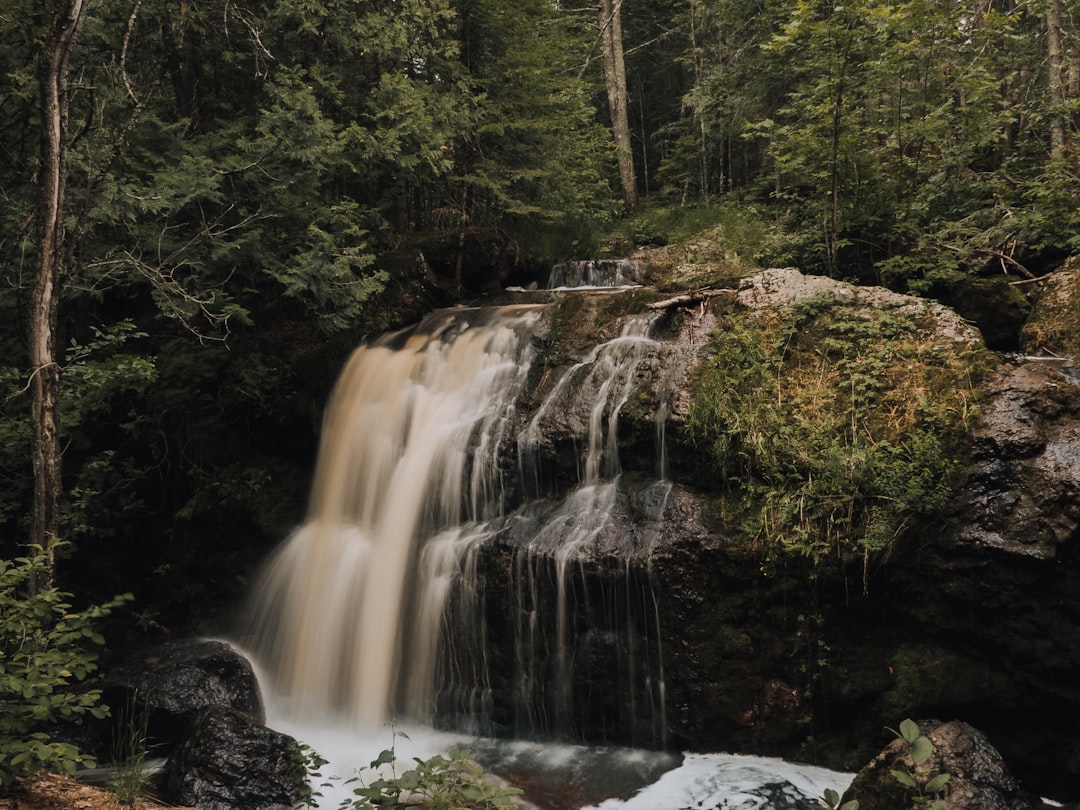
left=253, top=309, right=548, bottom=727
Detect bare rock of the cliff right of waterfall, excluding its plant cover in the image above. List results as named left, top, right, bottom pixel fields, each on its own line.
left=505, top=269, right=1080, bottom=800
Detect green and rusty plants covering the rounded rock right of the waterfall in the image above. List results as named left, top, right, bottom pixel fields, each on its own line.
left=687, top=296, right=985, bottom=574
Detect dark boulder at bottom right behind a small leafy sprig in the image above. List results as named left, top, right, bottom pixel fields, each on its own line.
left=843, top=720, right=1042, bottom=810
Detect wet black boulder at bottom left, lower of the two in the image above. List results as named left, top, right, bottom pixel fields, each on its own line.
left=165, top=707, right=307, bottom=810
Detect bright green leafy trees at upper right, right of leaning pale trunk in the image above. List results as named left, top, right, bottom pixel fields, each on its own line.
left=657, top=0, right=1080, bottom=295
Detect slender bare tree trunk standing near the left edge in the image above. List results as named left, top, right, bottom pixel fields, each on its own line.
left=29, top=0, right=85, bottom=588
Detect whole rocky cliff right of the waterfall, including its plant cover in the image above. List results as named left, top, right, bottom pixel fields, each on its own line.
left=489, top=263, right=1080, bottom=800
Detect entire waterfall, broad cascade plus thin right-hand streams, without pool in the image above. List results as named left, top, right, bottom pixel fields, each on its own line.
left=244, top=307, right=665, bottom=745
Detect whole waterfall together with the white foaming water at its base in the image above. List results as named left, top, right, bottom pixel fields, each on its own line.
left=243, top=300, right=847, bottom=810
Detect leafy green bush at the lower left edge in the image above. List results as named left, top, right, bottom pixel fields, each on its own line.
left=0, top=543, right=129, bottom=785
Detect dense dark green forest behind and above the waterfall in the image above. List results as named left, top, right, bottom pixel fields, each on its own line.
left=0, top=0, right=1080, bottom=799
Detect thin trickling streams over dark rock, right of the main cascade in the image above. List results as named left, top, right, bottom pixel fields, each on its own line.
left=445, top=315, right=665, bottom=746
